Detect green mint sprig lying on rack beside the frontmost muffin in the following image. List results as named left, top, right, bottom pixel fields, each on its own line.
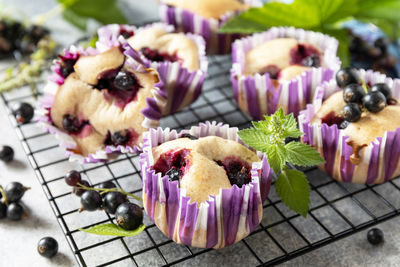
left=238, top=108, right=325, bottom=217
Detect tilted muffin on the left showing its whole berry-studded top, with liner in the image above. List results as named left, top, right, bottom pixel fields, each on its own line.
left=41, top=47, right=166, bottom=162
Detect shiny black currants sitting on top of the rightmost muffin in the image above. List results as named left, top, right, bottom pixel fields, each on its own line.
left=336, top=67, right=396, bottom=124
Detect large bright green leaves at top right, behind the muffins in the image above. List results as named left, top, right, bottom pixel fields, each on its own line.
left=220, top=0, right=400, bottom=65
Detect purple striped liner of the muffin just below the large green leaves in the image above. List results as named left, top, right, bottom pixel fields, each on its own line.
left=231, top=27, right=341, bottom=120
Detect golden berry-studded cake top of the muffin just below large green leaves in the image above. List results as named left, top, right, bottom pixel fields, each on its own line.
left=245, top=38, right=323, bottom=80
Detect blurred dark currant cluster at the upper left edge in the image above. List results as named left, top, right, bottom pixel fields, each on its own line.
left=0, top=19, right=50, bottom=57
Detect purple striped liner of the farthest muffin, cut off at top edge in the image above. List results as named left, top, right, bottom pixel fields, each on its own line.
left=159, top=0, right=262, bottom=54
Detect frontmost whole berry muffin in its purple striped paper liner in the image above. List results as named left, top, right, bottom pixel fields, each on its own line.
left=140, top=122, right=272, bottom=248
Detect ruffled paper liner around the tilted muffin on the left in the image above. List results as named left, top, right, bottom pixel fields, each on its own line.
left=36, top=46, right=166, bottom=164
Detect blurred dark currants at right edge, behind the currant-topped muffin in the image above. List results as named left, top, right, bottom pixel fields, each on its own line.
left=349, top=34, right=398, bottom=78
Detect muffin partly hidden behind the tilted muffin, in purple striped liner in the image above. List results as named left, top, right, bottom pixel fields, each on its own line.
left=97, top=23, right=208, bottom=115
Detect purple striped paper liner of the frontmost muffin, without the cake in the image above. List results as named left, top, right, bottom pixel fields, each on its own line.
left=140, top=122, right=273, bottom=249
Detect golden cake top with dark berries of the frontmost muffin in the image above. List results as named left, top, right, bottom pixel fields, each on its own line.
left=152, top=136, right=260, bottom=205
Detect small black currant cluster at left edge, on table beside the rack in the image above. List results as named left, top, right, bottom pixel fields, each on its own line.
left=0, top=182, right=30, bottom=221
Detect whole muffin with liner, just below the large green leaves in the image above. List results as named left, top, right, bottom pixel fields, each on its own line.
left=231, top=27, right=340, bottom=120
